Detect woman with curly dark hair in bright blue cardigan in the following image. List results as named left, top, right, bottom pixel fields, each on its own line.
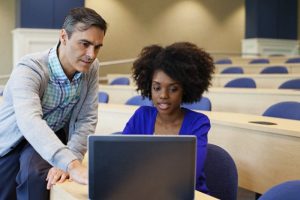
left=123, top=42, right=214, bottom=193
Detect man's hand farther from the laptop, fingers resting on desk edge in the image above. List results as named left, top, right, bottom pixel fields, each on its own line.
left=46, top=167, right=69, bottom=190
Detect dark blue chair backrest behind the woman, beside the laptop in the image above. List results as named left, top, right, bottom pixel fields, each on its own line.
left=204, top=144, right=238, bottom=200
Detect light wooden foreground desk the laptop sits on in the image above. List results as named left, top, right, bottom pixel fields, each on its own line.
left=50, top=181, right=216, bottom=200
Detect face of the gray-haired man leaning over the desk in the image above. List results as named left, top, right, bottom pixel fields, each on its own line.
left=59, top=25, right=104, bottom=75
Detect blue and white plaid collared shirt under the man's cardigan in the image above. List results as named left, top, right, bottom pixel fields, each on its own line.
left=42, top=46, right=82, bottom=131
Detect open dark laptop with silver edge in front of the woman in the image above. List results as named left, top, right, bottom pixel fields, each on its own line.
left=88, top=135, right=196, bottom=200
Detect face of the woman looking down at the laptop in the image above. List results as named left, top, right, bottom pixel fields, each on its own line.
left=151, top=70, right=183, bottom=115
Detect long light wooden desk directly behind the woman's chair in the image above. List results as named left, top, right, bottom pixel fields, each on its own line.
left=96, top=104, right=300, bottom=193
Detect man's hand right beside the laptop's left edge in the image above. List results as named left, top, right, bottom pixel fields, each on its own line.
left=67, top=160, right=88, bottom=185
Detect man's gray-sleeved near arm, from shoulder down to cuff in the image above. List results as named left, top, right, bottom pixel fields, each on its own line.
left=9, top=59, right=77, bottom=171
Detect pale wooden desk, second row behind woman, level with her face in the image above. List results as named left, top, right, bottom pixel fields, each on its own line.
left=99, top=85, right=300, bottom=115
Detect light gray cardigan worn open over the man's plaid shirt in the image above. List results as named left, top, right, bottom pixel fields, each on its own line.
left=0, top=50, right=99, bottom=170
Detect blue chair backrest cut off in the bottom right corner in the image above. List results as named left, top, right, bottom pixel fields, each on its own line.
left=258, top=180, right=300, bottom=200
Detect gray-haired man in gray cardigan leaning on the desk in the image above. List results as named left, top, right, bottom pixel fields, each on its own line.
left=0, top=8, right=107, bottom=200
